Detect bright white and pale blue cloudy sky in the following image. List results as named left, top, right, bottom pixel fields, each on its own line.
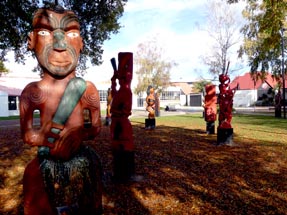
left=3, top=0, right=249, bottom=83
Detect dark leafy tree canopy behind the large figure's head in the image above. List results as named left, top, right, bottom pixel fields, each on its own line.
left=0, top=0, right=127, bottom=72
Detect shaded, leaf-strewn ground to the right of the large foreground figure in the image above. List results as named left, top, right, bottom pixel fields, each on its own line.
left=93, top=123, right=287, bottom=214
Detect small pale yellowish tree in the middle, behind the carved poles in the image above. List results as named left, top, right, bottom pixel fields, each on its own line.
left=135, top=40, right=176, bottom=95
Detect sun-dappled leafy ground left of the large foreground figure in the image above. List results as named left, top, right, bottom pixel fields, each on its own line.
left=0, top=128, right=36, bottom=215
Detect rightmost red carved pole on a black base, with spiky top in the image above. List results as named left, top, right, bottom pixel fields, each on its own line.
left=217, top=63, right=235, bottom=144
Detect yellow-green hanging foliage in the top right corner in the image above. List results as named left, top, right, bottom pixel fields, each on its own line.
left=240, top=0, right=287, bottom=78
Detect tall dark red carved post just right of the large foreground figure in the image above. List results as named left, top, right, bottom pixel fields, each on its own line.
left=110, top=52, right=135, bottom=182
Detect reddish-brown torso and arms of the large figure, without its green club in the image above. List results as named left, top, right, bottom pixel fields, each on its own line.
left=21, top=76, right=100, bottom=159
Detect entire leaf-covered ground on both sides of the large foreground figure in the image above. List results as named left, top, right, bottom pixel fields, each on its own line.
left=0, top=115, right=287, bottom=215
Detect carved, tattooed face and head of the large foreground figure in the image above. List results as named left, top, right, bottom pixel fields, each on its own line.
left=28, top=9, right=83, bottom=77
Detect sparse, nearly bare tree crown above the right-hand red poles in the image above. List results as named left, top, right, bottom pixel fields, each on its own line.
left=201, top=1, right=244, bottom=76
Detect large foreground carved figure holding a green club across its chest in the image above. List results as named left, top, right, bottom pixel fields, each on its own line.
left=20, top=6, right=102, bottom=215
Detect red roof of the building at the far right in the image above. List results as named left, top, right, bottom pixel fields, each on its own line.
left=229, top=72, right=287, bottom=90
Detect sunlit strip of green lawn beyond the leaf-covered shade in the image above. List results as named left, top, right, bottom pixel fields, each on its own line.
left=131, top=114, right=287, bottom=144
